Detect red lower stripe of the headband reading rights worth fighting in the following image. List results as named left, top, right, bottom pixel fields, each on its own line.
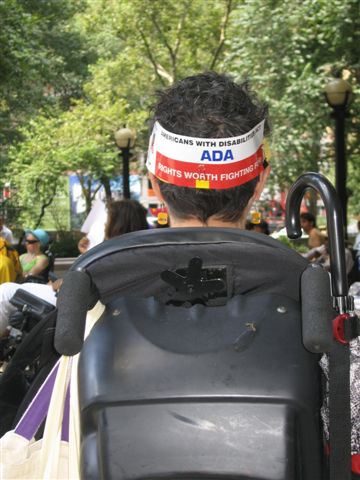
left=155, top=146, right=264, bottom=189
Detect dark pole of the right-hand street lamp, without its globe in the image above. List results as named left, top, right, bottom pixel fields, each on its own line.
left=334, top=106, right=347, bottom=239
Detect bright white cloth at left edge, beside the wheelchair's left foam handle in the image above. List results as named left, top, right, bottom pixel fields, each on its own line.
left=0, top=282, right=56, bottom=335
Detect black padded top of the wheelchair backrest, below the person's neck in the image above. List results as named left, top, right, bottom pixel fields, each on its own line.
left=72, top=227, right=308, bottom=304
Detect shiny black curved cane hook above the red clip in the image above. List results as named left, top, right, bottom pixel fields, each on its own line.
left=286, top=173, right=350, bottom=313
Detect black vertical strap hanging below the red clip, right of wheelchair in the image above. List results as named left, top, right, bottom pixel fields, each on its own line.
left=329, top=341, right=351, bottom=480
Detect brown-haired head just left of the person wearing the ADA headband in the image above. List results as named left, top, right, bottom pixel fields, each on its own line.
left=105, top=199, right=148, bottom=240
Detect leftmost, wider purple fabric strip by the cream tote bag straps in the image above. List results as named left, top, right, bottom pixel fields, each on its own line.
left=14, top=360, right=60, bottom=440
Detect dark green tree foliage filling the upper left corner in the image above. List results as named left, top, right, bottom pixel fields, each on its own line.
left=0, top=0, right=95, bottom=174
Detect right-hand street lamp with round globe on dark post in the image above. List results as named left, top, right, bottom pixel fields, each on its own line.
left=325, top=78, right=352, bottom=238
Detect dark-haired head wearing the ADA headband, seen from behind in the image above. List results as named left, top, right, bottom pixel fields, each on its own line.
left=147, top=72, right=269, bottom=226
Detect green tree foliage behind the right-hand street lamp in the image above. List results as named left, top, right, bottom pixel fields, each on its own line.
left=226, top=0, right=360, bottom=212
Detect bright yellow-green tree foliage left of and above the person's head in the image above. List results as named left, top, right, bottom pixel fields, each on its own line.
left=6, top=0, right=236, bottom=226
